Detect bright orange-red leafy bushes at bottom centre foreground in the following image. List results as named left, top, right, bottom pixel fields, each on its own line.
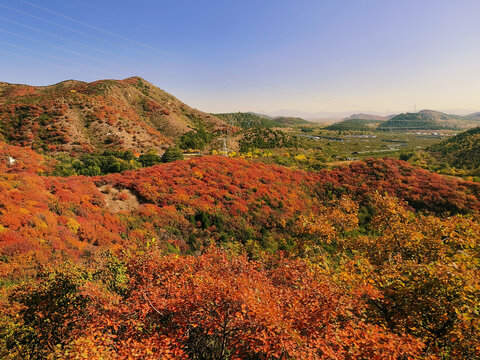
left=25, top=249, right=422, bottom=359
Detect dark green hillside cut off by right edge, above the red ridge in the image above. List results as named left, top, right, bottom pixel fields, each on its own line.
left=427, top=127, right=480, bottom=170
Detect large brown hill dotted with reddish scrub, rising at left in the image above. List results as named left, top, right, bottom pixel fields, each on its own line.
left=0, top=77, right=224, bottom=153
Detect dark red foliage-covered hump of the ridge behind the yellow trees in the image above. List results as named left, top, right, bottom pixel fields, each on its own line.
left=319, top=159, right=480, bottom=213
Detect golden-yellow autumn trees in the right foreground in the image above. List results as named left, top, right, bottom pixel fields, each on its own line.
left=341, top=196, right=480, bottom=359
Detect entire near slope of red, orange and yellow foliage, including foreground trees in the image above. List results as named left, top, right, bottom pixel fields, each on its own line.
left=0, top=146, right=480, bottom=359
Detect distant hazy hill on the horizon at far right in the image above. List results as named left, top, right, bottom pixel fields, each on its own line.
left=378, top=110, right=478, bottom=130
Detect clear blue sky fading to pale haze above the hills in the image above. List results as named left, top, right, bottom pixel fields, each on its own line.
left=0, top=0, right=480, bottom=113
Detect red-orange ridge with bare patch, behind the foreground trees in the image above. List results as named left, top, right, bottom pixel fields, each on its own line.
left=0, top=148, right=480, bottom=277
